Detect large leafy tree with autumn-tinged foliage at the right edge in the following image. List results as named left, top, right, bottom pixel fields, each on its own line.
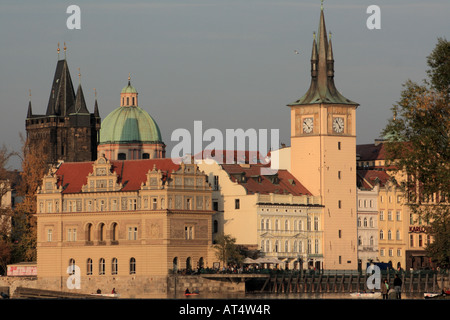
left=383, top=39, right=450, bottom=267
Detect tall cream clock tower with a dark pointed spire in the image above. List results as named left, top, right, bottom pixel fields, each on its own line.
left=288, top=5, right=358, bottom=270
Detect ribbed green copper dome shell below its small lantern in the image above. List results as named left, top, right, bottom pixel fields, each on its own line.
left=100, top=106, right=162, bottom=144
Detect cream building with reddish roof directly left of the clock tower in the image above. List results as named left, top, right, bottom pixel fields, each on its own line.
left=197, top=160, right=323, bottom=269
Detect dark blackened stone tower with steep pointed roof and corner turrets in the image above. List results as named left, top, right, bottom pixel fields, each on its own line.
left=25, top=48, right=101, bottom=164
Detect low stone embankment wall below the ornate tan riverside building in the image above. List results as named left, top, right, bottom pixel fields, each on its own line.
left=0, top=275, right=245, bottom=299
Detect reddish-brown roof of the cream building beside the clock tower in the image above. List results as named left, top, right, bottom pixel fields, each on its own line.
left=222, top=164, right=312, bottom=196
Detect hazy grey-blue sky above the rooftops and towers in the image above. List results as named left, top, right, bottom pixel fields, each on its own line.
left=0, top=0, right=450, bottom=168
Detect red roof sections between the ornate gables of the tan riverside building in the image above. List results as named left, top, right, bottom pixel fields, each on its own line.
left=56, top=158, right=180, bottom=193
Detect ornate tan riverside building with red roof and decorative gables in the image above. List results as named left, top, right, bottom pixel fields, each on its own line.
left=36, top=157, right=215, bottom=291
